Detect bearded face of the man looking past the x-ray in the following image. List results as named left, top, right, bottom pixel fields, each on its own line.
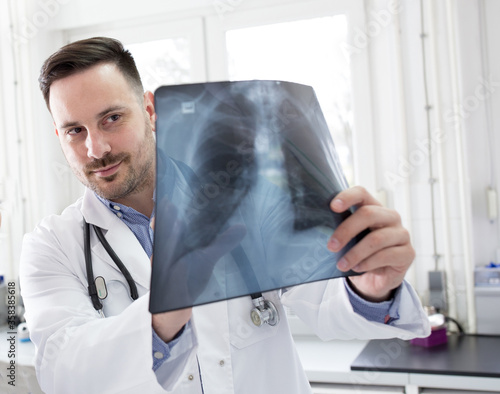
left=49, top=63, right=155, bottom=203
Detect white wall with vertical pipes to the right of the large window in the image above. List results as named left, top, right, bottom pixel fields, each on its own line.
left=388, top=0, right=500, bottom=331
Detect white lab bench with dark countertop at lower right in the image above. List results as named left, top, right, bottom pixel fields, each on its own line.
left=295, top=336, right=500, bottom=394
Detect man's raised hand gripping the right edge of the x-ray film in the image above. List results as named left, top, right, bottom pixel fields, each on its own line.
left=328, top=187, right=415, bottom=302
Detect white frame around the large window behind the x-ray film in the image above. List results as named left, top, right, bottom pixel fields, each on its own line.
left=205, top=0, right=377, bottom=192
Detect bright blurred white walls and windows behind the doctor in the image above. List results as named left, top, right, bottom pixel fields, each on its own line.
left=0, top=0, right=500, bottom=334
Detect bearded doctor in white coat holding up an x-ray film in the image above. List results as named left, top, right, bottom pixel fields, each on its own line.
left=20, top=38, right=429, bottom=394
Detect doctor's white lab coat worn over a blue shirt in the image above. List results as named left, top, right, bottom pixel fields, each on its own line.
left=20, top=190, right=429, bottom=394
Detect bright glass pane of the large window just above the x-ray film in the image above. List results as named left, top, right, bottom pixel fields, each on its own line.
left=226, top=15, right=354, bottom=184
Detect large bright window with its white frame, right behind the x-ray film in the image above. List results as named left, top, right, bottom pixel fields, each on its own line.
left=206, top=0, right=377, bottom=191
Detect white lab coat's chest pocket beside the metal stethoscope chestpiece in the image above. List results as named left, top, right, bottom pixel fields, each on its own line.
left=228, top=293, right=283, bottom=349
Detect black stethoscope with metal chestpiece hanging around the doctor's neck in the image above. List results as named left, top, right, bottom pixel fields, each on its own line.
left=83, top=219, right=280, bottom=327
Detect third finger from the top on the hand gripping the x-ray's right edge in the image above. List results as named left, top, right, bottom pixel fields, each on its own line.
left=337, top=227, right=410, bottom=272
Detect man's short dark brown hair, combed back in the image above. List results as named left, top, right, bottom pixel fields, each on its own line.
left=38, top=37, right=144, bottom=111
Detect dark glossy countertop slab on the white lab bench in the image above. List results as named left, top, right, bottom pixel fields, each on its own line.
left=351, top=335, right=500, bottom=378
